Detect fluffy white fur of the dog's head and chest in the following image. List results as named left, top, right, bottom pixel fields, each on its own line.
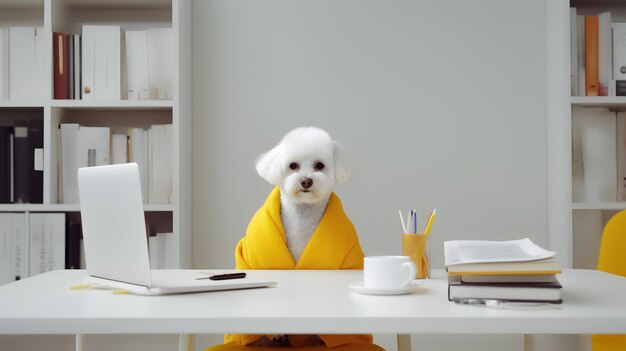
left=256, top=127, right=350, bottom=262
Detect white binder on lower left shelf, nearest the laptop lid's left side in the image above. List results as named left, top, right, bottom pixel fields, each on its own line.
left=29, top=213, right=65, bottom=275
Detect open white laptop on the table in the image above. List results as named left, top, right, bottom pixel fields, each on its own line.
left=78, top=163, right=276, bottom=295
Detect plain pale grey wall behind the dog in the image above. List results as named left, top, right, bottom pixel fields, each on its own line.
left=193, top=0, right=547, bottom=350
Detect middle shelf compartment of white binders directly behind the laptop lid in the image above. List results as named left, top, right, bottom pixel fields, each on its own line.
left=50, top=107, right=174, bottom=205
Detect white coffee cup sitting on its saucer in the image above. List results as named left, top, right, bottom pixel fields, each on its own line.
left=363, top=256, right=417, bottom=289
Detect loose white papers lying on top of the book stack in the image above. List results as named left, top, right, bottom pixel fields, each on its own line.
left=443, top=238, right=556, bottom=266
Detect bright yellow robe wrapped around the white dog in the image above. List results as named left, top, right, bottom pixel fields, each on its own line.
left=224, top=187, right=372, bottom=347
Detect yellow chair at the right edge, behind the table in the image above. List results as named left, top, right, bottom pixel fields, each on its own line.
left=591, top=211, right=626, bottom=351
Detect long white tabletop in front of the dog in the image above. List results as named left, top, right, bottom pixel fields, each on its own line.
left=0, top=270, right=626, bottom=334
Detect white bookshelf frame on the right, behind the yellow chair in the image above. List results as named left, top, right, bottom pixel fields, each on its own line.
left=546, top=0, right=626, bottom=269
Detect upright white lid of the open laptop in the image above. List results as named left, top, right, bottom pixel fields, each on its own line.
left=78, top=163, right=151, bottom=287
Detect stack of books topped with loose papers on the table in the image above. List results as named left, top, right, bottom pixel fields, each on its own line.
left=444, top=238, right=562, bottom=303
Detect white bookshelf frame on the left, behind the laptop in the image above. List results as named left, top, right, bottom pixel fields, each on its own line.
left=0, top=0, right=191, bottom=278
